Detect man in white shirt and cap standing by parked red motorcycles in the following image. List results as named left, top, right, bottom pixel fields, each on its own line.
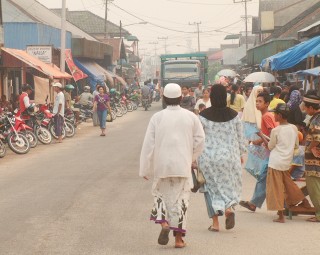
left=52, top=82, right=65, bottom=143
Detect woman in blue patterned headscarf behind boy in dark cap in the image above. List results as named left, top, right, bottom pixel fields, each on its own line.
left=288, top=90, right=305, bottom=130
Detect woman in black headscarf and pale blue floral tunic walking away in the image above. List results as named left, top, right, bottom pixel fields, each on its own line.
left=198, top=84, right=246, bottom=232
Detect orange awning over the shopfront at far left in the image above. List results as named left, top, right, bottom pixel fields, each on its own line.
left=1, top=48, right=72, bottom=80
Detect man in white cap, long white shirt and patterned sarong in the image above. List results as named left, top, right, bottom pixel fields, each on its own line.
left=139, top=83, right=204, bottom=248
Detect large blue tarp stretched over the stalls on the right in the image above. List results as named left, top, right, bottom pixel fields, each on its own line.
left=260, top=36, right=320, bottom=71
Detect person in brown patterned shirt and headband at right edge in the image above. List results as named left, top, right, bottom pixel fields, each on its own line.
left=303, top=95, right=320, bottom=222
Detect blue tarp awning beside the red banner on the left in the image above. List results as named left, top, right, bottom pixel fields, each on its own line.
left=73, top=58, right=105, bottom=91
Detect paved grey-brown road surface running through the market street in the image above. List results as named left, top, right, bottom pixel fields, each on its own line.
left=0, top=102, right=320, bottom=255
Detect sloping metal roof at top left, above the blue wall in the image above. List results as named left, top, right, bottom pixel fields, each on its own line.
left=3, top=0, right=97, bottom=41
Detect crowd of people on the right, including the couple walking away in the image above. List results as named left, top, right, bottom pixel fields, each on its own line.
left=139, top=78, right=320, bottom=248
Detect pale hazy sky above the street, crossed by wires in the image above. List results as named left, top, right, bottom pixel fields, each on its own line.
left=38, top=0, right=259, bottom=54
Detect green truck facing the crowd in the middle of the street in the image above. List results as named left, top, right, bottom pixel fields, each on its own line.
left=160, top=53, right=208, bottom=88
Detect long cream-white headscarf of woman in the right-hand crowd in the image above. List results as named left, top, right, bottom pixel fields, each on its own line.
left=242, top=86, right=263, bottom=129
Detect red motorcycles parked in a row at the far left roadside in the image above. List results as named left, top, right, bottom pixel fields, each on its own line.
left=0, top=97, right=76, bottom=158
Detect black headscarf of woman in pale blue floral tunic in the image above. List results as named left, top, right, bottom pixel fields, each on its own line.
left=200, top=84, right=238, bottom=122
